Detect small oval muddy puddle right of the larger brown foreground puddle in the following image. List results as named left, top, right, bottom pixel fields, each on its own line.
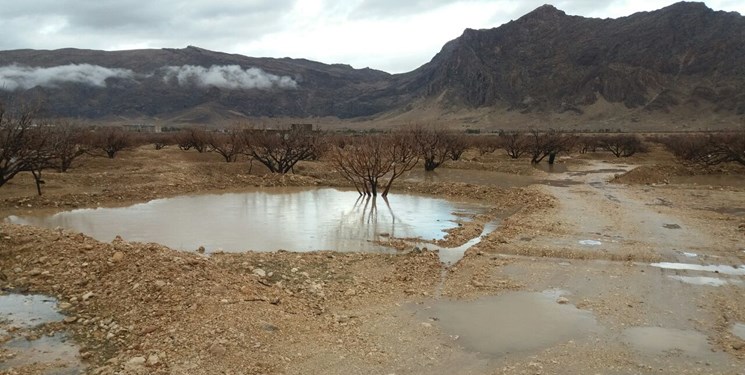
left=622, top=327, right=712, bottom=357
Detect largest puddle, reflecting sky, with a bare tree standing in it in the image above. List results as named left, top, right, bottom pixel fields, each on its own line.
left=6, top=188, right=484, bottom=252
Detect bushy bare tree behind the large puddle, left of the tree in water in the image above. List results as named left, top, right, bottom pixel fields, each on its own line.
left=246, top=129, right=321, bottom=174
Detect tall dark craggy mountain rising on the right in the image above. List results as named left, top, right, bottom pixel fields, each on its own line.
left=415, top=3, right=745, bottom=114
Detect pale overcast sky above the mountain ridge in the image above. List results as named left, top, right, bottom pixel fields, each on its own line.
left=0, top=0, right=745, bottom=73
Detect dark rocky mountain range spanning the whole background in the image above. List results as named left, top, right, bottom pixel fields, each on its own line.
left=0, top=2, right=745, bottom=126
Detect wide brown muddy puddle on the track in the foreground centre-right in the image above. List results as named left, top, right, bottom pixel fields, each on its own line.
left=415, top=292, right=600, bottom=356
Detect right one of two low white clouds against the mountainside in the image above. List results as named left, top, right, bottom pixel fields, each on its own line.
left=163, top=65, right=297, bottom=90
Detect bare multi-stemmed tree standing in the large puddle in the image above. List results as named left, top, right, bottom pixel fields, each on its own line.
left=331, top=131, right=419, bottom=197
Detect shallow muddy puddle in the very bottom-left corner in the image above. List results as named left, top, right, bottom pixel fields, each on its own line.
left=0, top=333, right=85, bottom=375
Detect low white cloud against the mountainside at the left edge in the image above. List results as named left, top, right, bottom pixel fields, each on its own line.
left=0, top=64, right=134, bottom=91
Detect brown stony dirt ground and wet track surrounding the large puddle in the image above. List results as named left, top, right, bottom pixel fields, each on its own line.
left=0, top=147, right=745, bottom=375
